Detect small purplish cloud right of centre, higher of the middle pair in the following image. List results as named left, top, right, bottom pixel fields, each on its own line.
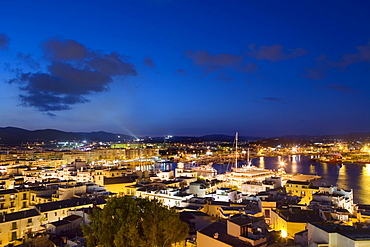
left=246, top=44, right=307, bottom=62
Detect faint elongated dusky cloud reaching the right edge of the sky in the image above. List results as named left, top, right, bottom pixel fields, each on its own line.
left=303, top=43, right=370, bottom=80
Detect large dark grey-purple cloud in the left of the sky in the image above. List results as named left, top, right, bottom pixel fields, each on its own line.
left=9, top=38, right=137, bottom=112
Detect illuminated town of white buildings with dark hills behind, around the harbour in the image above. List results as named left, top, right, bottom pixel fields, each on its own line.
left=0, top=127, right=370, bottom=247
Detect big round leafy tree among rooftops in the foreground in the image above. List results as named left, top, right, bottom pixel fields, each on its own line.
left=83, top=196, right=188, bottom=247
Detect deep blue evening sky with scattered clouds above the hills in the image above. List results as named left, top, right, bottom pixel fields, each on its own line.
left=0, top=0, right=370, bottom=137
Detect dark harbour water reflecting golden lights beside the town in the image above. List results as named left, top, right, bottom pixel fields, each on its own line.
left=157, top=155, right=370, bottom=204
